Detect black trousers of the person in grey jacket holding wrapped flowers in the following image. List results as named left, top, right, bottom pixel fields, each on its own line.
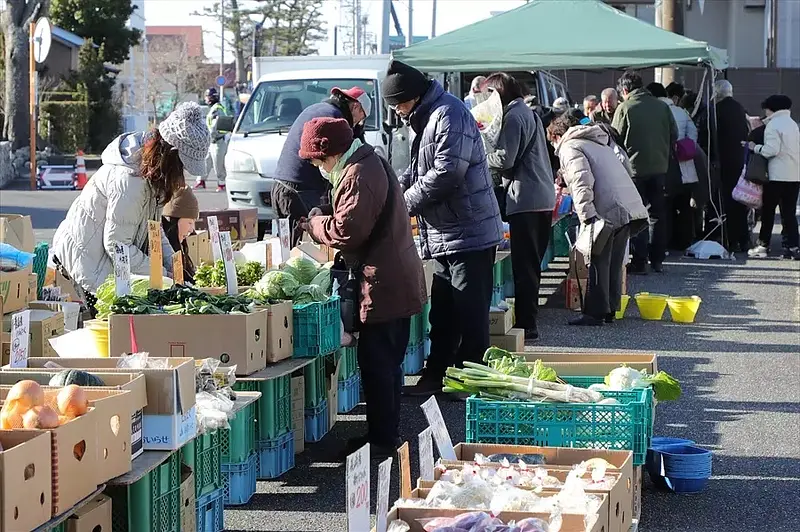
left=508, top=211, right=553, bottom=329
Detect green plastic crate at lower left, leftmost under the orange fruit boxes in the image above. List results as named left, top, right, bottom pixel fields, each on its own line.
left=106, top=451, right=181, bottom=532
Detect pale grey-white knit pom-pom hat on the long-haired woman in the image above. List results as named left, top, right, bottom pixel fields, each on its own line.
left=158, top=102, right=211, bottom=177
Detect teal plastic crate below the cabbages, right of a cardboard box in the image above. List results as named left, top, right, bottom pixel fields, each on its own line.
left=293, top=296, right=342, bottom=358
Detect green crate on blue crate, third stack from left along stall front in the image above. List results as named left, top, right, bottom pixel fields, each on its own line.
left=220, top=381, right=259, bottom=506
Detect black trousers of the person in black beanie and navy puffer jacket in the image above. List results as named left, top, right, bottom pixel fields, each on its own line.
left=422, top=248, right=495, bottom=381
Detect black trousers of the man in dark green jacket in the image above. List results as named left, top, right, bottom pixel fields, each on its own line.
left=631, top=175, right=667, bottom=267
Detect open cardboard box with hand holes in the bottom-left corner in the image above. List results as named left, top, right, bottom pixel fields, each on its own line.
left=0, top=430, right=53, bottom=532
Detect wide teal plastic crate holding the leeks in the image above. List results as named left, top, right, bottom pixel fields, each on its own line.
left=466, top=390, right=649, bottom=465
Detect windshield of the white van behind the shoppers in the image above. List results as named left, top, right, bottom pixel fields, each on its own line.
left=236, top=79, right=378, bottom=133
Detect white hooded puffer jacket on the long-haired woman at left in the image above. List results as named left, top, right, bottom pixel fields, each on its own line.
left=51, top=133, right=173, bottom=293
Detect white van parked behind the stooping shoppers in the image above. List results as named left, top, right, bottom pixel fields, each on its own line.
left=225, top=55, right=409, bottom=229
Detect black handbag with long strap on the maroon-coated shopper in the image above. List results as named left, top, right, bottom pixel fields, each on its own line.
left=331, top=157, right=397, bottom=333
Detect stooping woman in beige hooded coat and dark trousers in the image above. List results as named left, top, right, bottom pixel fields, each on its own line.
left=547, top=114, right=647, bottom=325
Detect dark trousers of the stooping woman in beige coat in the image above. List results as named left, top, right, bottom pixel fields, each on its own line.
left=583, top=225, right=631, bottom=319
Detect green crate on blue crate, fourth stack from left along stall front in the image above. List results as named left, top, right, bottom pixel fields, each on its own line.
left=248, top=375, right=294, bottom=482
